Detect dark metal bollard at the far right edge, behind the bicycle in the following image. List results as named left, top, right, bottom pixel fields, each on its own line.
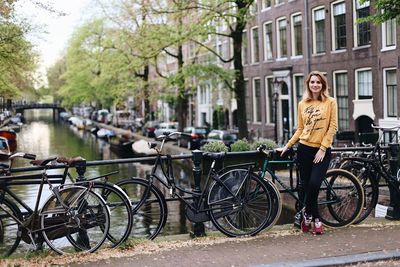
left=385, top=143, right=400, bottom=220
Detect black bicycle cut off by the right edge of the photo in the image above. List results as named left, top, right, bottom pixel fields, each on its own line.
left=340, top=125, right=400, bottom=223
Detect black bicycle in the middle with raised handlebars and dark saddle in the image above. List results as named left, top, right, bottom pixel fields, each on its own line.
left=117, top=132, right=280, bottom=239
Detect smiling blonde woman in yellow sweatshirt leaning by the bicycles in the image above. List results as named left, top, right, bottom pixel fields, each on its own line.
left=277, top=71, right=337, bottom=234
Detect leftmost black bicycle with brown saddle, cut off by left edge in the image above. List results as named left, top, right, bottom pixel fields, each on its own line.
left=0, top=152, right=110, bottom=257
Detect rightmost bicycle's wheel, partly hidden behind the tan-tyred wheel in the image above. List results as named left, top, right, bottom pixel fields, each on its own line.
left=341, top=160, right=379, bottom=224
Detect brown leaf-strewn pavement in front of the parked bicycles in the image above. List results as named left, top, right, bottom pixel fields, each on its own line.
left=62, top=219, right=400, bottom=267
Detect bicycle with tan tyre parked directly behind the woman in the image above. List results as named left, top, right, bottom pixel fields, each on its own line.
left=257, top=145, right=364, bottom=227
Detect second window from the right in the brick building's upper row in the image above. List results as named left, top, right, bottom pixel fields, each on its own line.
left=354, top=0, right=371, bottom=46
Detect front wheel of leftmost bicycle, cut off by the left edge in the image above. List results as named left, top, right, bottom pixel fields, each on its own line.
left=0, top=198, right=22, bottom=257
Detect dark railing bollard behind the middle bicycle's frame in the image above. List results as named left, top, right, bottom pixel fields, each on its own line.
left=191, top=150, right=206, bottom=237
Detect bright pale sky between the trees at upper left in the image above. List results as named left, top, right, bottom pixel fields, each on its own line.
left=17, top=0, right=94, bottom=85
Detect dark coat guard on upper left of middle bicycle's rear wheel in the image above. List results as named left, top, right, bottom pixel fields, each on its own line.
left=208, top=169, right=248, bottom=205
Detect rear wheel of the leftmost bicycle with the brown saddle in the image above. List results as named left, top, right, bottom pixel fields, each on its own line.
left=40, top=186, right=110, bottom=254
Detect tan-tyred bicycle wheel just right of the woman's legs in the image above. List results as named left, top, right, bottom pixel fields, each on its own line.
left=318, top=169, right=364, bottom=227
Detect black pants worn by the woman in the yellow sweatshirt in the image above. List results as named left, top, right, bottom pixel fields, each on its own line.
left=297, top=144, right=331, bottom=218
